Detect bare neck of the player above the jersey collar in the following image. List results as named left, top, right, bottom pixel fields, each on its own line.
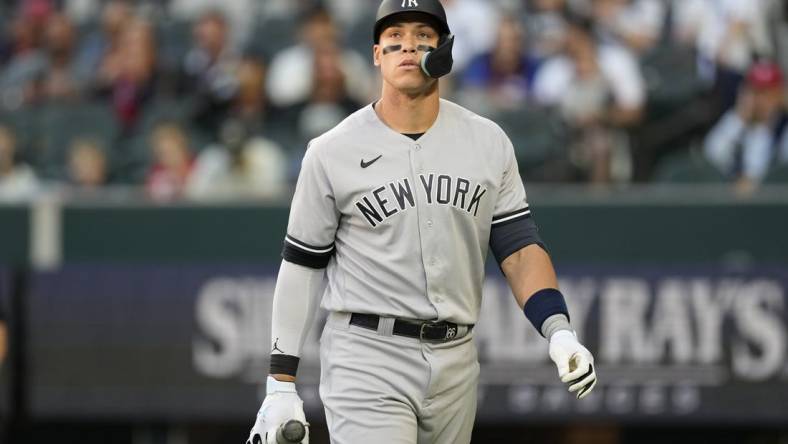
left=375, top=82, right=440, bottom=134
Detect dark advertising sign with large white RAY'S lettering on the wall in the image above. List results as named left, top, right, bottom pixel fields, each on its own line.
left=29, top=266, right=788, bottom=423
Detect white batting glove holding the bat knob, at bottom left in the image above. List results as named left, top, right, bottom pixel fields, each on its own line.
left=246, top=376, right=309, bottom=444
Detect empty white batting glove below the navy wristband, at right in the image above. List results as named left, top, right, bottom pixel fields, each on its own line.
left=550, top=330, right=596, bottom=399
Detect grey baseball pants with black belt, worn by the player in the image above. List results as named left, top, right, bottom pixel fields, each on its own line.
left=320, top=312, right=479, bottom=444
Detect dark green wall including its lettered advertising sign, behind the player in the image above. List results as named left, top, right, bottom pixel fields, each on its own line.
left=0, top=186, right=788, bottom=424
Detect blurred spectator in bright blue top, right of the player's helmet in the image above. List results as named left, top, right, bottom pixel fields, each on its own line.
left=461, top=15, right=537, bottom=110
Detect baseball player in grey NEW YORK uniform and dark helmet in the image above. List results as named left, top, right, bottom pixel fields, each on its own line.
left=248, top=0, right=596, bottom=444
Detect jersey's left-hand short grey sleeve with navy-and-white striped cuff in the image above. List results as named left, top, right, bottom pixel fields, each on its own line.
left=282, top=144, right=339, bottom=268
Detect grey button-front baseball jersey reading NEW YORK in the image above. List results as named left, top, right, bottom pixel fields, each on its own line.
left=283, top=99, right=539, bottom=324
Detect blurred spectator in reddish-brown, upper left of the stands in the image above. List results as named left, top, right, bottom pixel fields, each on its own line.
left=95, top=18, right=159, bottom=132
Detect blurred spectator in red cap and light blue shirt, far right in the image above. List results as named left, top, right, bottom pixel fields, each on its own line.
left=704, top=61, right=788, bottom=193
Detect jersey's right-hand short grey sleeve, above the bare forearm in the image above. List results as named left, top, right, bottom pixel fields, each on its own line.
left=490, top=134, right=544, bottom=264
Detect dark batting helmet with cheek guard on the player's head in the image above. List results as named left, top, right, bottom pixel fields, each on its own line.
left=372, top=0, right=454, bottom=79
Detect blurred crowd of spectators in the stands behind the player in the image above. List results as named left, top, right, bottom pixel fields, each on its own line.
left=0, top=0, right=788, bottom=200
